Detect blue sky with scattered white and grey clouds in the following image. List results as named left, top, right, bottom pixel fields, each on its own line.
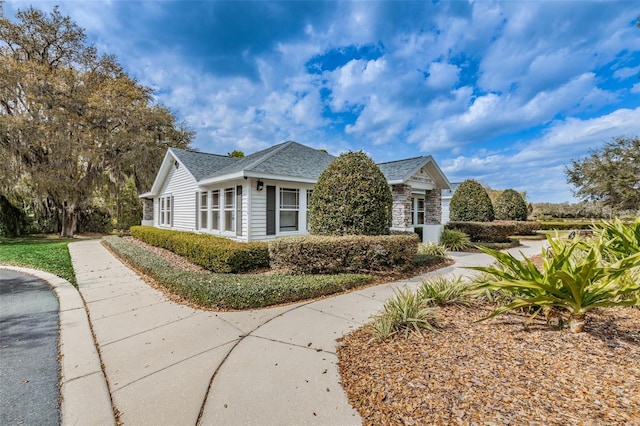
left=4, top=0, right=640, bottom=202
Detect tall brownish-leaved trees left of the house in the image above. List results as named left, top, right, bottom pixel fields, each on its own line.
left=0, top=7, right=194, bottom=237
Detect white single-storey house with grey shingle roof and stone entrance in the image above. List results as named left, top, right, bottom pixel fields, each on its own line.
left=140, top=141, right=450, bottom=242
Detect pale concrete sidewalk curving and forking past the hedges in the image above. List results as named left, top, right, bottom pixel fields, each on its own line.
left=62, top=240, right=543, bottom=425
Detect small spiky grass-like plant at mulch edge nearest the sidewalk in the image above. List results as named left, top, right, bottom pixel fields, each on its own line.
left=373, top=288, right=435, bottom=340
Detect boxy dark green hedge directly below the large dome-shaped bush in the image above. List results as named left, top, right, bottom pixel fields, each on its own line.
left=269, top=234, right=418, bottom=274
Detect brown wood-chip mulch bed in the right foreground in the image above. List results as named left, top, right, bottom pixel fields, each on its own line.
left=338, top=307, right=640, bottom=425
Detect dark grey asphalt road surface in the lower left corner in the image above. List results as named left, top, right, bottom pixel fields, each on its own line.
left=0, top=269, right=60, bottom=425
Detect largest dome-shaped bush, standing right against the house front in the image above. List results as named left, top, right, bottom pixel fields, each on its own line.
left=309, top=152, right=393, bottom=235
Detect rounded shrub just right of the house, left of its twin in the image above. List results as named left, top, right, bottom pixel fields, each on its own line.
left=449, top=179, right=495, bottom=222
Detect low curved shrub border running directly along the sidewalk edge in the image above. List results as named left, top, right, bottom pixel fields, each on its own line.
left=103, top=236, right=373, bottom=309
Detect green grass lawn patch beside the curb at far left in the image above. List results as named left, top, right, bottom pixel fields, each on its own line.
left=0, top=236, right=76, bottom=285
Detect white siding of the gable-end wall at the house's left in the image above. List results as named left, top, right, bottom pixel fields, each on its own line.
left=154, top=161, right=198, bottom=231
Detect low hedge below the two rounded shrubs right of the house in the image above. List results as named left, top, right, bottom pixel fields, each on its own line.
left=445, top=221, right=540, bottom=243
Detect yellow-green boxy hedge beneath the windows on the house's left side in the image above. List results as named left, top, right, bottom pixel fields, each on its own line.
left=131, top=226, right=269, bottom=273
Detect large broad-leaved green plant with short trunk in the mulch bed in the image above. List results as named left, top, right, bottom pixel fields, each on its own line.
left=470, top=238, right=640, bottom=332
